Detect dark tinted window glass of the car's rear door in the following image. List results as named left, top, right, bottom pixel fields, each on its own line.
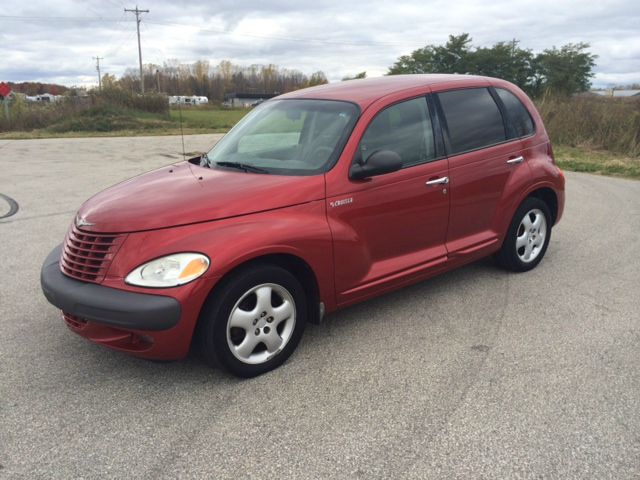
left=438, top=88, right=507, bottom=154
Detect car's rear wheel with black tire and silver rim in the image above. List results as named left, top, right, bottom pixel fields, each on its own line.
left=496, top=197, right=552, bottom=272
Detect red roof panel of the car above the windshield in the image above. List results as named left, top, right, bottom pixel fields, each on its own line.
left=278, top=73, right=496, bottom=109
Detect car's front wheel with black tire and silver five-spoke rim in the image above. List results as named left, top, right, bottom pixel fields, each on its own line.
left=198, top=264, right=307, bottom=377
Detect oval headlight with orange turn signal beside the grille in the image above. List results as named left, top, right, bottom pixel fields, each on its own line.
left=125, top=253, right=209, bottom=287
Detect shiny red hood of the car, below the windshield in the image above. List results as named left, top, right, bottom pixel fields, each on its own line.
left=78, top=162, right=325, bottom=233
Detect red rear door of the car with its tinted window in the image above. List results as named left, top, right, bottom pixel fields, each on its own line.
left=435, top=85, right=528, bottom=257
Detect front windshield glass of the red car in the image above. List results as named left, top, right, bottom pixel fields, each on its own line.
left=202, top=99, right=359, bottom=175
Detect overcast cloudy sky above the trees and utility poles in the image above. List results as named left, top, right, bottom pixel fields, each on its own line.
left=0, top=0, right=640, bottom=87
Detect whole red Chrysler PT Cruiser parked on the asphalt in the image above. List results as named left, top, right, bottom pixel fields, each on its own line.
left=41, top=75, right=564, bottom=377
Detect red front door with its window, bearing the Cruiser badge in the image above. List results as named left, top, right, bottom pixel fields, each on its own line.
left=327, top=97, right=449, bottom=305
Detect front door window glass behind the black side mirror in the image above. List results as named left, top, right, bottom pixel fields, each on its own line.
left=358, top=97, right=436, bottom=167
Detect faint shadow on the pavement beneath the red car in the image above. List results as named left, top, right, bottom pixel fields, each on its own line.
left=48, top=258, right=509, bottom=386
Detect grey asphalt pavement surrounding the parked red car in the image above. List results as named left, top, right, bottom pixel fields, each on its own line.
left=0, top=135, right=640, bottom=479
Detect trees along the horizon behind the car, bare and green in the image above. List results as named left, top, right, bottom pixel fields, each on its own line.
left=7, top=33, right=597, bottom=102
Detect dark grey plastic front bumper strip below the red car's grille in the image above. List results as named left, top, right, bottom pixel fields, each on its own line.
left=40, top=245, right=181, bottom=330
